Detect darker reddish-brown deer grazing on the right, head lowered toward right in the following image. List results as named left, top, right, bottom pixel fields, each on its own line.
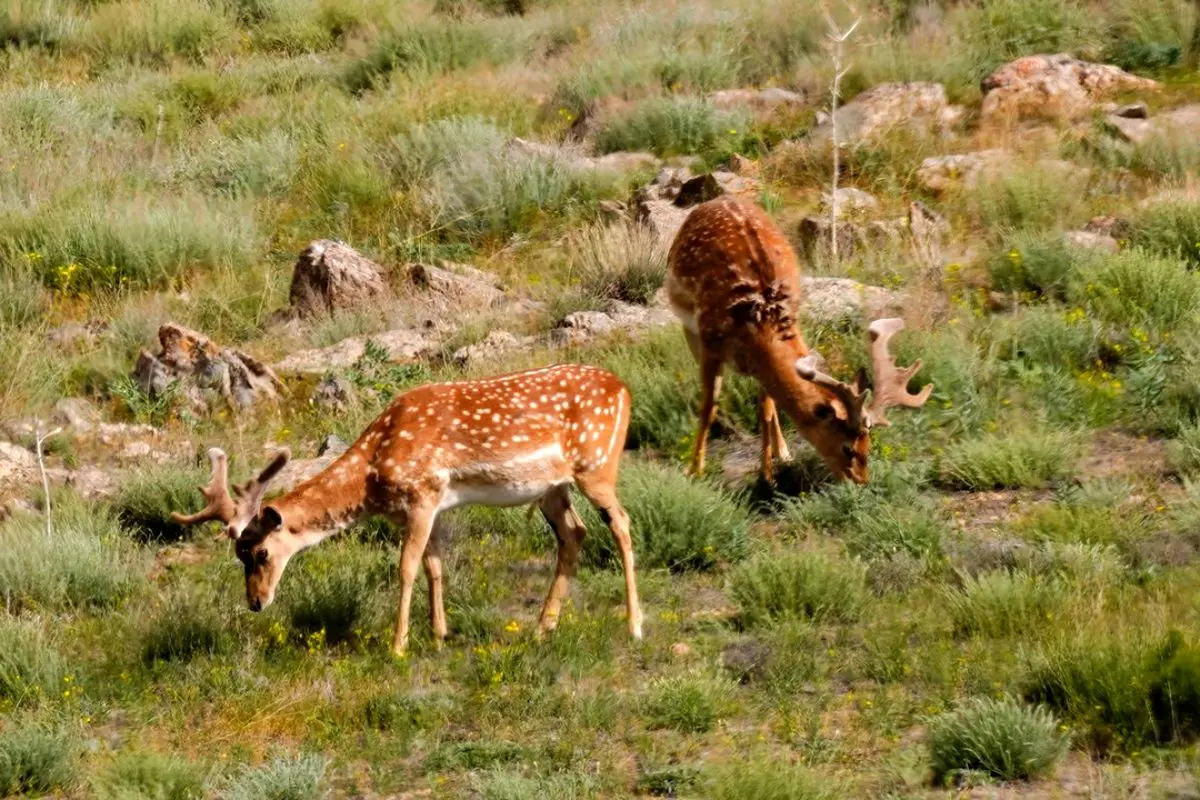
left=666, top=196, right=934, bottom=483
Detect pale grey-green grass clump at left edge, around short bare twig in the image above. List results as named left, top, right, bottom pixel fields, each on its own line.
left=0, top=495, right=145, bottom=610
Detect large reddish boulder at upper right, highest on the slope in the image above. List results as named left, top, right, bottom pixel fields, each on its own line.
left=979, top=53, right=1159, bottom=126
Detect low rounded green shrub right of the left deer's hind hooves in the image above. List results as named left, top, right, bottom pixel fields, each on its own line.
left=730, top=553, right=866, bottom=626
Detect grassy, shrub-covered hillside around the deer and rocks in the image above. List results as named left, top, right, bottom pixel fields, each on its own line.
left=0, top=0, right=1200, bottom=800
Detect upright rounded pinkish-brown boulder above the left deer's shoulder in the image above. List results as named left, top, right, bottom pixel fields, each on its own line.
left=290, top=239, right=388, bottom=317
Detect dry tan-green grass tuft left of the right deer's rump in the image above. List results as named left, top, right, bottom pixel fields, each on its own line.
left=572, top=224, right=667, bottom=305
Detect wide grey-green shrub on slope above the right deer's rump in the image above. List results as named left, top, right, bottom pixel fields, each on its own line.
left=596, top=97, right=750, bottom=156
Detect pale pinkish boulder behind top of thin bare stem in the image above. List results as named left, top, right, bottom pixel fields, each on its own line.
left=809, top=83, right=958, bottom=145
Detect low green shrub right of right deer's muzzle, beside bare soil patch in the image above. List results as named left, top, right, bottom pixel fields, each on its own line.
left=938, top=432, right=1075, bottom=492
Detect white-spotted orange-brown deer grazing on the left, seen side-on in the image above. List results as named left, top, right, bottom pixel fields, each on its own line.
left=174, top=365, right=642, bottom=655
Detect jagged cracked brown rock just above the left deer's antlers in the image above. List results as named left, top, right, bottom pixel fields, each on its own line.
left=133, top=323, right=283, bottom=411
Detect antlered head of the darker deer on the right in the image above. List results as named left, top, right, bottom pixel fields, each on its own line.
left=796, top=318, right=934, bottom=483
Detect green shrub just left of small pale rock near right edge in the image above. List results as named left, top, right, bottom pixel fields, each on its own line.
left=988, top=230, right=1090, bottom=300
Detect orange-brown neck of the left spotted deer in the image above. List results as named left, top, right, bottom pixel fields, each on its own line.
left=270, top=445, right=370, bottom=547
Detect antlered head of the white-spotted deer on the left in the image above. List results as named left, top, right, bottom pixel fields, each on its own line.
left=172, top=447, right=301, bottom=612
